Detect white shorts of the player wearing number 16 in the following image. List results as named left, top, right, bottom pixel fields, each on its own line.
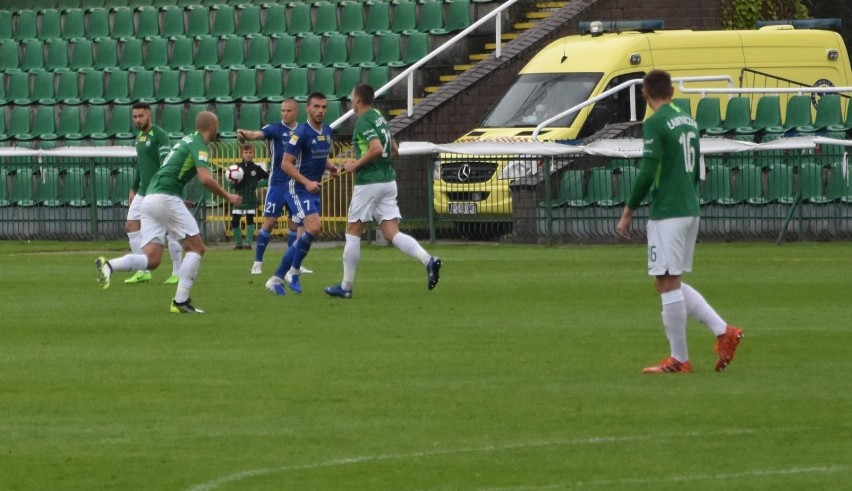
left=648, top=217, right=699, bottom=276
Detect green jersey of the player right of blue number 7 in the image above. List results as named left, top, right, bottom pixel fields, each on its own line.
left=352, top=109, right=396, bottom=185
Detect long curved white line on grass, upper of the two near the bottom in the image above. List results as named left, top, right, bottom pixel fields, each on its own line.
left=187, top=427, right=820, bottom=491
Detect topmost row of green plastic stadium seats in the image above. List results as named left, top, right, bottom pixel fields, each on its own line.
left=0, top=0, right=471, bottom=40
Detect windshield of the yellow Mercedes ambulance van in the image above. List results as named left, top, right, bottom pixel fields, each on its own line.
left=482, top=73, right=603, bottom=128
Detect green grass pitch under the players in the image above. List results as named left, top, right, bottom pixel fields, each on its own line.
left=0, top=242, right=852, bottom=491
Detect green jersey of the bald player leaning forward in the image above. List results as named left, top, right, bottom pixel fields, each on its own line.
left=148, top=132, right=210, bottom=196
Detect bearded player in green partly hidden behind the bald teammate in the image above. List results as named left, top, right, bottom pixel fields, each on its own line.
left=124, top=102, right=182, bottom=285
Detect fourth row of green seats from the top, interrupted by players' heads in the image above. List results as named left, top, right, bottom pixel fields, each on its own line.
left=0, top=100, right=343, bottom=145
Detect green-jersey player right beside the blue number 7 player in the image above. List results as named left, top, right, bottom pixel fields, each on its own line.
left=325, top=84, right=441, bottom=298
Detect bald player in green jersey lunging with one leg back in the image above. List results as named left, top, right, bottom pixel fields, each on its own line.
left=95, top=111, right=243, bottom=314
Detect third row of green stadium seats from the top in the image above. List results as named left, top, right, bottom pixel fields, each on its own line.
left=0, top=66, right=391, bottom=106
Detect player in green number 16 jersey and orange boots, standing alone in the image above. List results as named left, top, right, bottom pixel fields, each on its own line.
left=616, top=70, right=743, bottom=373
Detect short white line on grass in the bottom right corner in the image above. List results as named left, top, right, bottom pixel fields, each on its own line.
left=480, top=466, right=849, bottom=491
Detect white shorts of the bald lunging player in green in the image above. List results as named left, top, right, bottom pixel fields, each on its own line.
left=142, top=194, right=200, bottom=247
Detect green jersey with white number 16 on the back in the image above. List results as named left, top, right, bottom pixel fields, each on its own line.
left=627, top=103, right=701, bottom=220
